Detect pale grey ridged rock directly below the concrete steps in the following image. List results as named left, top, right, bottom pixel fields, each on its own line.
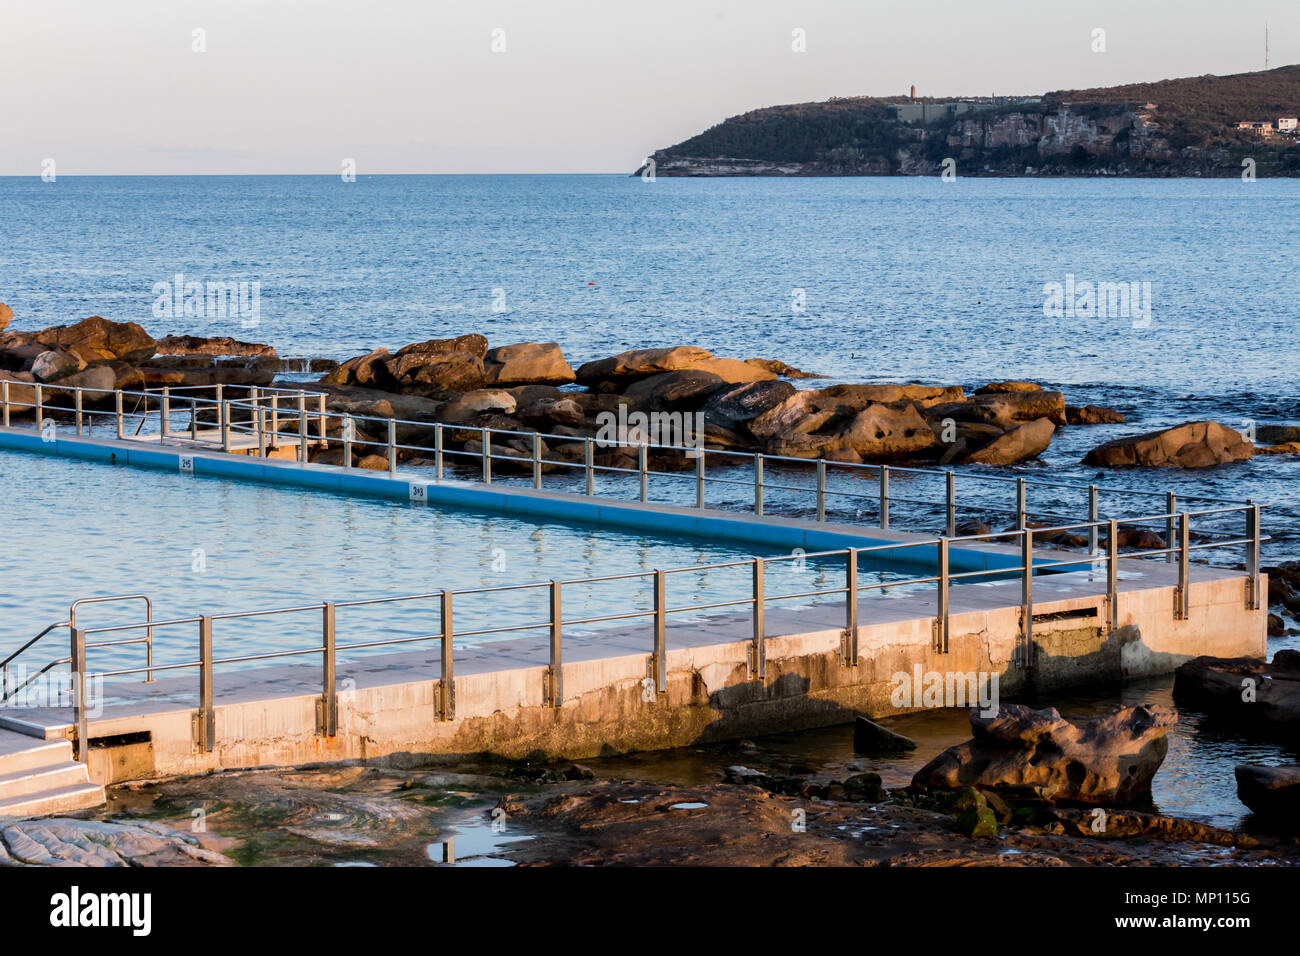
left=0, top=818, right=233, bottom=866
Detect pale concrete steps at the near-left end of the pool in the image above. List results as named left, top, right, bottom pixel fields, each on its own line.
left=0, top=730, right=104, bottom=818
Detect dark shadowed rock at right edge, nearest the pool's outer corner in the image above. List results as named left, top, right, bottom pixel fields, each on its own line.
left=1174, top=650, right=1300, bottom=745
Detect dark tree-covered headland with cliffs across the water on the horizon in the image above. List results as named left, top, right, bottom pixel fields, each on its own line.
left=638, top=65, right=1300, bottom=176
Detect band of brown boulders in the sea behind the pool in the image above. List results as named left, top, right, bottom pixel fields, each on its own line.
left=0, top=307, right=1300, bottom=470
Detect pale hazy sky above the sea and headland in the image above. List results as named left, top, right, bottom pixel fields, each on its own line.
left=0, top=0, right=1300, bottom=176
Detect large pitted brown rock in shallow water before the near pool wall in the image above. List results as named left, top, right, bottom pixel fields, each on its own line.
left=911, top=704, right=1178, bottom=804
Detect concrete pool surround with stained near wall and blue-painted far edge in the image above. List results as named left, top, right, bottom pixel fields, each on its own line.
left=0, top=429, right=1268, bottom=782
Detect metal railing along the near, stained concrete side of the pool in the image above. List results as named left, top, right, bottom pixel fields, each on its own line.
left=4, top=505, right=1262, bottom=760
